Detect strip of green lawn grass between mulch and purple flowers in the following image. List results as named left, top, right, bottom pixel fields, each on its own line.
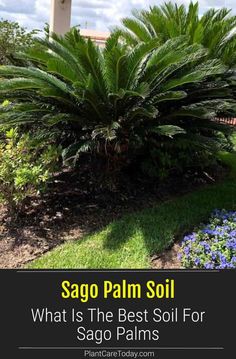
left=28, top=148, right=236, bottom=269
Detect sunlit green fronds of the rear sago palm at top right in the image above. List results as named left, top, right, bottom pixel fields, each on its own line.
left=115, top=2, right=236, bottom=65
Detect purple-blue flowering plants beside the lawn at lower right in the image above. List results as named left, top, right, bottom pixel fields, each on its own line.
left=179, top=210, right=236, bottom=269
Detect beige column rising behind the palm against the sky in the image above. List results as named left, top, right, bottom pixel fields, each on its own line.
left=50, top=0, right=72, bottom=35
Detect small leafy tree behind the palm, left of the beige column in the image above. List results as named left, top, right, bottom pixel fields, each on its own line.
left=0, top=19, right=37, bottom=65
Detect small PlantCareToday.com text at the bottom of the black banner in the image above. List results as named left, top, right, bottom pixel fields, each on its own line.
left=84, top=349, right=155, bottom=359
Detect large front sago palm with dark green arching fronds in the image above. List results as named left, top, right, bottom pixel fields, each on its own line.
left=0, top=29, right=235, bottom=179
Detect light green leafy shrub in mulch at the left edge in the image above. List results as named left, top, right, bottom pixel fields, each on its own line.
left=0, top=128, right=60, bottom=215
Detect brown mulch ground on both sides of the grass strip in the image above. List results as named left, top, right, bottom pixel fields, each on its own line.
left=0, top=166, right=229, bottom=268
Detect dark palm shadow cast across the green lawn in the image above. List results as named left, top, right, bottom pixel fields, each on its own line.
left=103, top=180, right=236, bottom=255
